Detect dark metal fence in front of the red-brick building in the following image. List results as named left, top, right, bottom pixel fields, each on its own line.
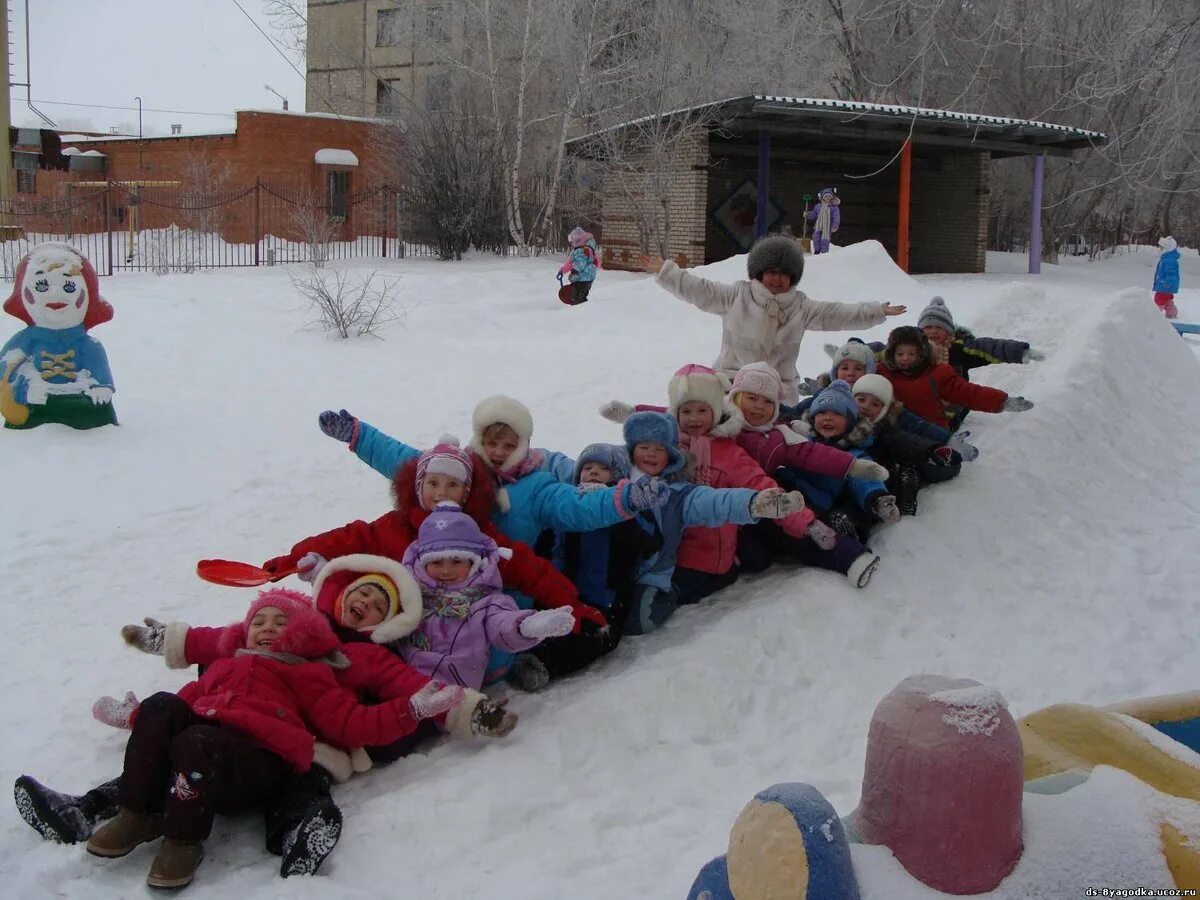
left=0, top=179, right=576, bottom=278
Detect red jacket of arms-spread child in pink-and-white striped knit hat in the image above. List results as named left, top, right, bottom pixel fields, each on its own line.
left=263, top=457, right=606, bottom=632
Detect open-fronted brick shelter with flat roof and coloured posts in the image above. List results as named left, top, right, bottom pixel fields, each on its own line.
left=568, top=96, right=1105, bottom=272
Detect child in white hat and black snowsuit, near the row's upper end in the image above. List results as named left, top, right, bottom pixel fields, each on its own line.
left=851, top=374, right=979, bottom=516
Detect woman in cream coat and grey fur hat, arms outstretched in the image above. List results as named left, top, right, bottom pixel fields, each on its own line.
left=638, top=235, right=907, bottom=403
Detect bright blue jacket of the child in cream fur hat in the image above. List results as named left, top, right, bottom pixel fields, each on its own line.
left=354, top=420, right=629, bottom=546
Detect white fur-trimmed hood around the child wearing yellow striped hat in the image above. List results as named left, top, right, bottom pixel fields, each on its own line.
left=312, top=553, right=422, bottom=643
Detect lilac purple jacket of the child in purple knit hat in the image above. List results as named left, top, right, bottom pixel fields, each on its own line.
left=389, top=542, right=540, bottom=690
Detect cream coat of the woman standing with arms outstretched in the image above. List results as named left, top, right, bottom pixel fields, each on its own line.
left=655, top=260, right=886, bottom=403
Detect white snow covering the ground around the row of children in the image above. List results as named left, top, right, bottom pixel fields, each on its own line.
left=0, top=244, right=1200, bottom=900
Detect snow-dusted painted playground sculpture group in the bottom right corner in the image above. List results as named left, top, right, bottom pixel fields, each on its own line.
left=689, top=676, right=1200, bottom=900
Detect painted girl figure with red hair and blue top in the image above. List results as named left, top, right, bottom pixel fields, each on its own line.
left=0, top=244, right=116, bottom=428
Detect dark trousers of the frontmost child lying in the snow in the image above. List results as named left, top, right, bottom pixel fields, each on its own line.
left=119, top=691, right=293, bottom=841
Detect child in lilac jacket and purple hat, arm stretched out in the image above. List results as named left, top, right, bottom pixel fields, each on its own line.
left=389, top=504, right=575, bottom=690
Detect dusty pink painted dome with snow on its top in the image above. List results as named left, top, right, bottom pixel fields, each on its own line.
left=851, top=674, right=1024, bottom=894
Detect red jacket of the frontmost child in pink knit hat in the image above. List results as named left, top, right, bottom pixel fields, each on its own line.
left=162, top=611, right=416, bottom=772
